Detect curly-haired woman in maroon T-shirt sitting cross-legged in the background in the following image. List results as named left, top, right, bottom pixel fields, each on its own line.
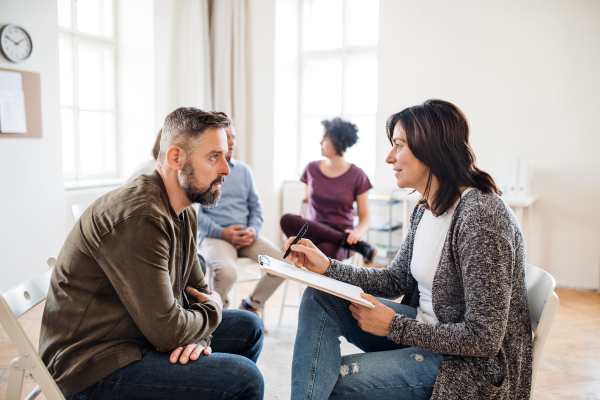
left=281, top=118, right=376, bottom=263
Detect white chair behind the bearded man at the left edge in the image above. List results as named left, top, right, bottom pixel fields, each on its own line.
left=0, top=258, right=65, bottom=400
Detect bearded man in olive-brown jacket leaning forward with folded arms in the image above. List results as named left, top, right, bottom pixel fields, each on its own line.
left=40, top=107, right=264, bottom=399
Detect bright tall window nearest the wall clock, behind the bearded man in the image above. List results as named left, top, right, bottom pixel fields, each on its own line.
left=58, top=0, right=118, bottom=181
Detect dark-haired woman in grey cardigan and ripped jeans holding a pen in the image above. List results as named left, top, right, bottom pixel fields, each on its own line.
left=286, top=100, right=533, bottom=399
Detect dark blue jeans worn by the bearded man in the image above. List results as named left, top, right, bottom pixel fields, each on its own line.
left=67, top=310, right=264, bottom=400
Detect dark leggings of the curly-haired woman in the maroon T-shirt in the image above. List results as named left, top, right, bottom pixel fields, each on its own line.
left=280, top=214, right=346, bottom=258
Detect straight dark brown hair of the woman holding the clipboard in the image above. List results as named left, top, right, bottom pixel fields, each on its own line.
left=386, top=99, right=502, bottom=216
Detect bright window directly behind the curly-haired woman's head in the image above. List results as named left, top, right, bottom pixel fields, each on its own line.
left=299, top=0, right=379, bottom=176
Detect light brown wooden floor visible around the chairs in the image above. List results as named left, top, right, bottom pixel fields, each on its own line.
left=0, top=284, right=600, bottom=400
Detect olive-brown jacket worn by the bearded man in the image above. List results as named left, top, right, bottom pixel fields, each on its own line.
left=40, top=171, right=221, bottom=396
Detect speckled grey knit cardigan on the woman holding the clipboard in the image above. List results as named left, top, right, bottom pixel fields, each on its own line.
left=326, top=190, right=533, bottom=400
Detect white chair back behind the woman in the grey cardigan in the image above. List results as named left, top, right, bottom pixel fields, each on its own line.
left=525, top=264, right=558, bottom=399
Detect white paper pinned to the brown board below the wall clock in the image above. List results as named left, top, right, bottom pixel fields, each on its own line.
left=0, top=71, right=27, bottom=133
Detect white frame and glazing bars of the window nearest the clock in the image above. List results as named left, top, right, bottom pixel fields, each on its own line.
left=58, top=0, right=120, bottom=183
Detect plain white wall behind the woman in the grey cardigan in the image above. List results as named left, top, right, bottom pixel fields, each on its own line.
left=375, top=0, right=600, bottom=289
